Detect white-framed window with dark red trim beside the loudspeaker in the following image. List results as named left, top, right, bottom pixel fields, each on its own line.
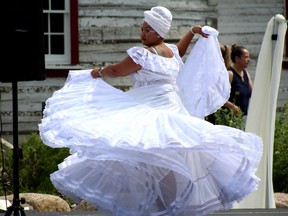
left=43, top=0, right=79, bottom=68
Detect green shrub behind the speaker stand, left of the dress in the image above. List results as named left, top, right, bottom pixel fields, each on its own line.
left=0, top=134, right=70, bottom=195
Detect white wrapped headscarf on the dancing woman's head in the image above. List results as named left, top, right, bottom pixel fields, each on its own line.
left=144, top=6, right=172, bottom=38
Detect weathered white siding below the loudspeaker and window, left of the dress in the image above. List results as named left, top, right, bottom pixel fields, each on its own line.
left=0, top=78, right=65, bottom=143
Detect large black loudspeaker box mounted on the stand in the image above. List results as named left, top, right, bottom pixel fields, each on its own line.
left=0, top=0, right=45, bottom=82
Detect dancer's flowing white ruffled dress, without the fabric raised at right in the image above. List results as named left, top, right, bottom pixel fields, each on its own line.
left=39, top=27, right=262, bottom=216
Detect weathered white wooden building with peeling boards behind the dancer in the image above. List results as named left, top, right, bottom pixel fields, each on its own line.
left=0, top=0, right=288, bottom=143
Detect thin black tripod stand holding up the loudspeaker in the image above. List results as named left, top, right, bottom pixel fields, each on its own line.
left=5, top=81, right=25, bottom=216
